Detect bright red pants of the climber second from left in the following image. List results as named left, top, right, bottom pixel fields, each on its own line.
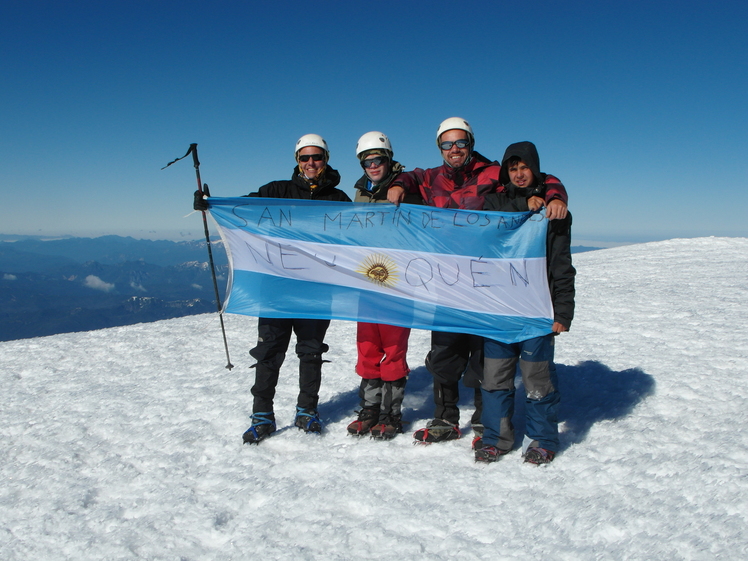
left=356, top=323, right=410, bottom=382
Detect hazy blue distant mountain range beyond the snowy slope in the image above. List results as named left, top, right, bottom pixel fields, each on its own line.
left=0, top=234, right=599, bottom=341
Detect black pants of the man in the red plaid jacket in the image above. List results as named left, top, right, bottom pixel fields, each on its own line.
left=426, top=331, right=483, bottom=424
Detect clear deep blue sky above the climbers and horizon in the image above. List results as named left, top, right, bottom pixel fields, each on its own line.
left=0, top=0, right=748, bottom=245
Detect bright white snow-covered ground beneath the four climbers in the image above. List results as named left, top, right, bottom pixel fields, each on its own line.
left=0, top=238, right=748, bottom=560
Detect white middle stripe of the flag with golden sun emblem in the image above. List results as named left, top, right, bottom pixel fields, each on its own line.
left=223, top=225, right=553, bottom=317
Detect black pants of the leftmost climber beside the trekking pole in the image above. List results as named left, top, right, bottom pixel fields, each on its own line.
left=249, top=318, right=330, bottom=413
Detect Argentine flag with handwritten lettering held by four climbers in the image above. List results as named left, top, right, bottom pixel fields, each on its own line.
left=208, top=197, right=553, bottom=343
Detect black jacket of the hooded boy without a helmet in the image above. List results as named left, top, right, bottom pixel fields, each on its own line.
left=483, top=186, right=576, bottom=329
